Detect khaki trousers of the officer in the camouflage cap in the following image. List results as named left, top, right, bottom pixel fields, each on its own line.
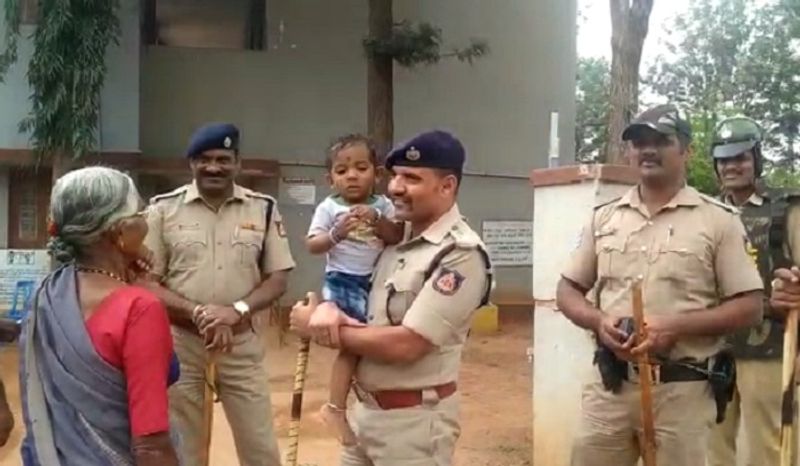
left=570, top=381, right=716, bottom=466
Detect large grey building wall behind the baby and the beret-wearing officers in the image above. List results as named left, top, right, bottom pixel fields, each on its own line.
left=136, top=0, right=576, bottom=297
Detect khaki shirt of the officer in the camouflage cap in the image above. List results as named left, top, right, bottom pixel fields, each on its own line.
left=562, top=187, right=764, bottom=360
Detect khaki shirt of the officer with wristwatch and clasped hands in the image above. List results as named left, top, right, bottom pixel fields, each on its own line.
left=145, top=184, right=295, bottom=305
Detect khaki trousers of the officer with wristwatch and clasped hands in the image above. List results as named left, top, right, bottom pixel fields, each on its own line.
left=169, top=326, right=281, bottom=466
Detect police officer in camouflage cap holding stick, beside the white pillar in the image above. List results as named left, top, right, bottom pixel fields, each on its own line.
left=556, top=105, right=763, bottom=466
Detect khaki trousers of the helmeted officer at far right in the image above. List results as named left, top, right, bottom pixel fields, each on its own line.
left=708, top=359, right=782, bottom=466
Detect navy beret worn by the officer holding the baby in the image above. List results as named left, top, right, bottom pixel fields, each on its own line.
left=385, top=131, right=465, bottom=174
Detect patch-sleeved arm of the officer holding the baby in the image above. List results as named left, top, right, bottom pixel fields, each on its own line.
left=340, top=248, right=489, bottom=363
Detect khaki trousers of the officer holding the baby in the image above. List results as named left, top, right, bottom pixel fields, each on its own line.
left=341, top=390, right=461, bottom=466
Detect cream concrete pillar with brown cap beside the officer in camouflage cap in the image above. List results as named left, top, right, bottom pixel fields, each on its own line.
left=531, top=165, right=637, bottom=466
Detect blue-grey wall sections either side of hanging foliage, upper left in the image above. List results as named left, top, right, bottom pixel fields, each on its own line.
left=0, top=0, right=140, bottom=151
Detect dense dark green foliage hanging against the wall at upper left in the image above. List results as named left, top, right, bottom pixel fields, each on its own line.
left=0, top=0, right=120, bottom=162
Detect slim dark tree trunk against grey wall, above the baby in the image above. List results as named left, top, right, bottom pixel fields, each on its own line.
left=367, top=0, right=394, bottom=156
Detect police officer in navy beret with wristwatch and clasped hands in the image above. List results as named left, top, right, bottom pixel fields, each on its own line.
left=147, top=123, right=295, bottom=466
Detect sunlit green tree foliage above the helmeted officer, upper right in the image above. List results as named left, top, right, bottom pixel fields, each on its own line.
left=645, top=0, right=800, bottom=169
